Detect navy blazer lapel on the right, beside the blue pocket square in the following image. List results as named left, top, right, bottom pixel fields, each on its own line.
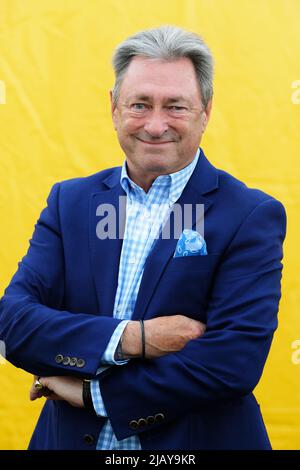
left=132, top=150, right=218, bottom=320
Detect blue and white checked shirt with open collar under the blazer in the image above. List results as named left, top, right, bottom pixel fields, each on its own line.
left=91, top=150, right=199, bottom=450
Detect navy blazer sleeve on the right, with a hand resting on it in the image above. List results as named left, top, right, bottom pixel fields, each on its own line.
left=99, top=198, right=286, bottom=439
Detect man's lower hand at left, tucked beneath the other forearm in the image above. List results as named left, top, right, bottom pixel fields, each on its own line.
left=30, top=376, right=84, bottom=408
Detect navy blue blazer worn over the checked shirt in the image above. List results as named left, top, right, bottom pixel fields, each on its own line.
left=0, top=151, right=286, bottom=450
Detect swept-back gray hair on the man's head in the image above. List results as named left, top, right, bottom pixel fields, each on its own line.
left=112, top=26, right=213, bottom=107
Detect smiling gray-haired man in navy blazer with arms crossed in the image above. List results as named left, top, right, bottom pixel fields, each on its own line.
left=0, top=27, right=285, bottom=450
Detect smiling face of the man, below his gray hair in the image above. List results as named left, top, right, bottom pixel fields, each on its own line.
left=112, top=57, right=211, bottom=186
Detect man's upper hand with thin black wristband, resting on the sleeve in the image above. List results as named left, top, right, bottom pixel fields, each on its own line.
left=122, top=315, right=206, bottom=359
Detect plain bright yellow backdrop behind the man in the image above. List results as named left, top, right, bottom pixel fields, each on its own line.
left=0, top=0, right=300, bottom=449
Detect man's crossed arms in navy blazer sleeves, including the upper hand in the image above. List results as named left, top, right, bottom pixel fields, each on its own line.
left=0, top=185, right=285, bottom=439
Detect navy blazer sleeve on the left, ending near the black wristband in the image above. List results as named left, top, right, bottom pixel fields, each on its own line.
left=0, top=183, right=121, bottom=377
